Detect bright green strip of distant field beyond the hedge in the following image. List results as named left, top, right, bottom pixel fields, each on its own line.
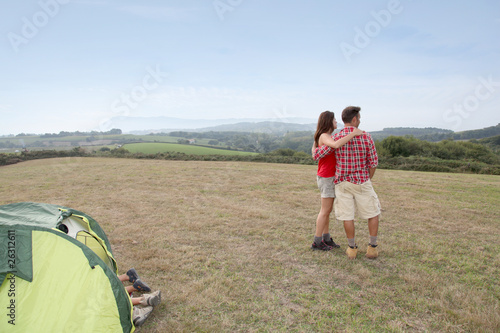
left=123, top=142, right=257, bottom=155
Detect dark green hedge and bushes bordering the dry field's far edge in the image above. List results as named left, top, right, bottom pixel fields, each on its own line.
left=0, top=136, right=500, bottom=175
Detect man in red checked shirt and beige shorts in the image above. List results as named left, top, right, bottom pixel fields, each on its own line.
left=314, top=106, right=380, bottom=259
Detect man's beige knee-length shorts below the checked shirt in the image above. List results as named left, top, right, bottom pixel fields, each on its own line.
left=334, top=180, right=380, bottom=221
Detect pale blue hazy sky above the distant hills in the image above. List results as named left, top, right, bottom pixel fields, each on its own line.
left=0, top=0, right=500, bottom=135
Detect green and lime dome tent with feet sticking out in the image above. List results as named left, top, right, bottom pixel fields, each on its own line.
left=0, top=202, right=134, bottom=332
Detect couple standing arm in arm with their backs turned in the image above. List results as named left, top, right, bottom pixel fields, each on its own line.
left=311, top=106, right=380, bottom=259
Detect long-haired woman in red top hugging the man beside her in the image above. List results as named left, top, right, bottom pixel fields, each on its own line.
left=311, top=111, right=363, bottom=251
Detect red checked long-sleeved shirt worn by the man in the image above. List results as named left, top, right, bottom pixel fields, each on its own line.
left=313, top=126, right=378, bottom=184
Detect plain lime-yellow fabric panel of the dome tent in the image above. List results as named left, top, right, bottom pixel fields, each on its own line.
left=0, top=231, right=133, bottom=332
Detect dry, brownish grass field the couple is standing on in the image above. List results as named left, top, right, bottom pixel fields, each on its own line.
left=0, top=158, right=500, bottom=332
